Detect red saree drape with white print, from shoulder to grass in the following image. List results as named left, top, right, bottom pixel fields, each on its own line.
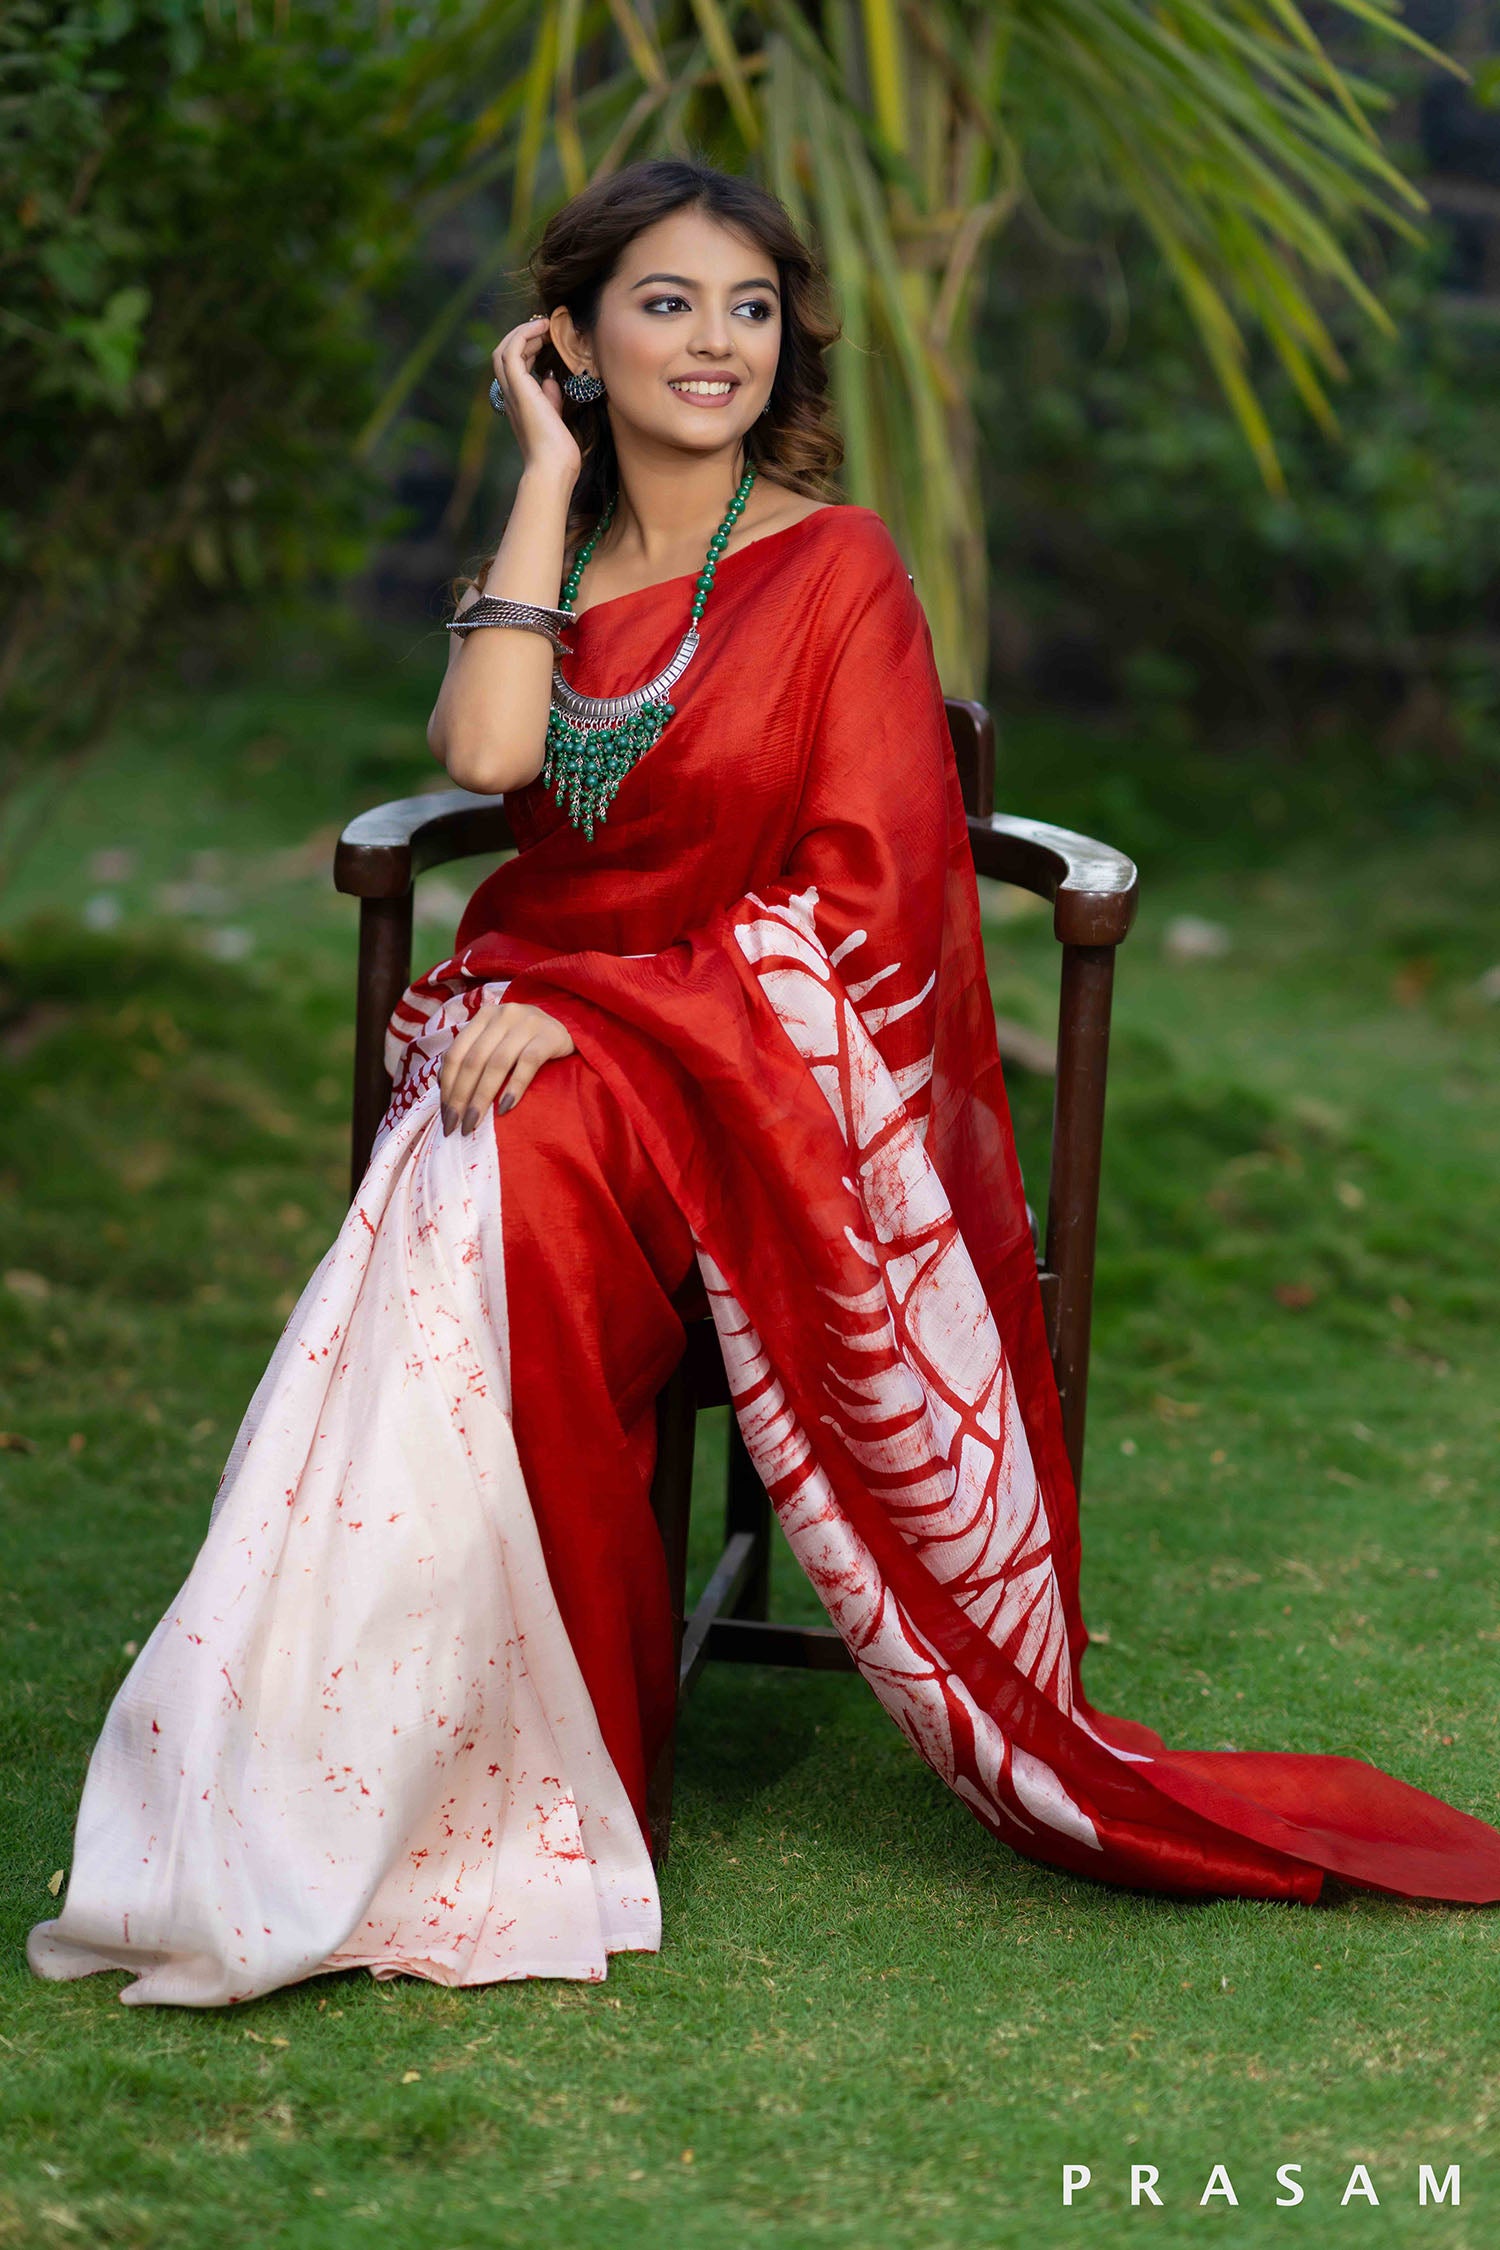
left=391, top=506, right=1500, bottom=1904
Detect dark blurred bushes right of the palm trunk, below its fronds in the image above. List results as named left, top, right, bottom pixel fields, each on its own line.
left=978, top=232, right=1500, bottom=763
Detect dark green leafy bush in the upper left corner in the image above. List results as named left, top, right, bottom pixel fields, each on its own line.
left=0, top=0, right=474, bottom=859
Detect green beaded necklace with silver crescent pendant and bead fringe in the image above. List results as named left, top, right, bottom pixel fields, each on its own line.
left=542, top=468, right=756, bottom=844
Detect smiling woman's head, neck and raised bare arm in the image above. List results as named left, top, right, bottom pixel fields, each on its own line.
left=427, top=182, right=841, bottom=792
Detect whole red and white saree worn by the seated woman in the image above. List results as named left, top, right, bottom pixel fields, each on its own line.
left=29, top=506, right=1500, bottom=2003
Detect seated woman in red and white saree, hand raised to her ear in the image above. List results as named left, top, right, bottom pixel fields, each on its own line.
left=29, top=162, right=1500, bottom=2005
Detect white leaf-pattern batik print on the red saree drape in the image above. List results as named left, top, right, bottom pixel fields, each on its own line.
left=719, top=887, right=1097, bottom=1850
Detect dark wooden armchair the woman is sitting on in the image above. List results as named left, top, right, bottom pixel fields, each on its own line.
left=333, top=698, right=1136, bottom=1861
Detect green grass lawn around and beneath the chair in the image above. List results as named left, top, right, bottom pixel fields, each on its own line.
left=0, top=621, right=1500, bottom=2250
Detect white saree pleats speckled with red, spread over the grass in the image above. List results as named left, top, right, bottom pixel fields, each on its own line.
left=27, top=1062, right=661, bottom=2007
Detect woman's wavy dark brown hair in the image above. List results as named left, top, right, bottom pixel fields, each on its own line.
left=454, top=155, right=843, bottom=594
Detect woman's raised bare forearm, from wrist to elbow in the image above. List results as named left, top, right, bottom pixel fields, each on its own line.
left=427, top=466, right=573, bottom=794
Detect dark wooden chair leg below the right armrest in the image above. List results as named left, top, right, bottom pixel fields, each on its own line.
left=1046, top=945, right=1115, bottom=1490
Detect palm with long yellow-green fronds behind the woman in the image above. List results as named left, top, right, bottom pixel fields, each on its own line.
left=364, top=0, right=1444, bottom=693
